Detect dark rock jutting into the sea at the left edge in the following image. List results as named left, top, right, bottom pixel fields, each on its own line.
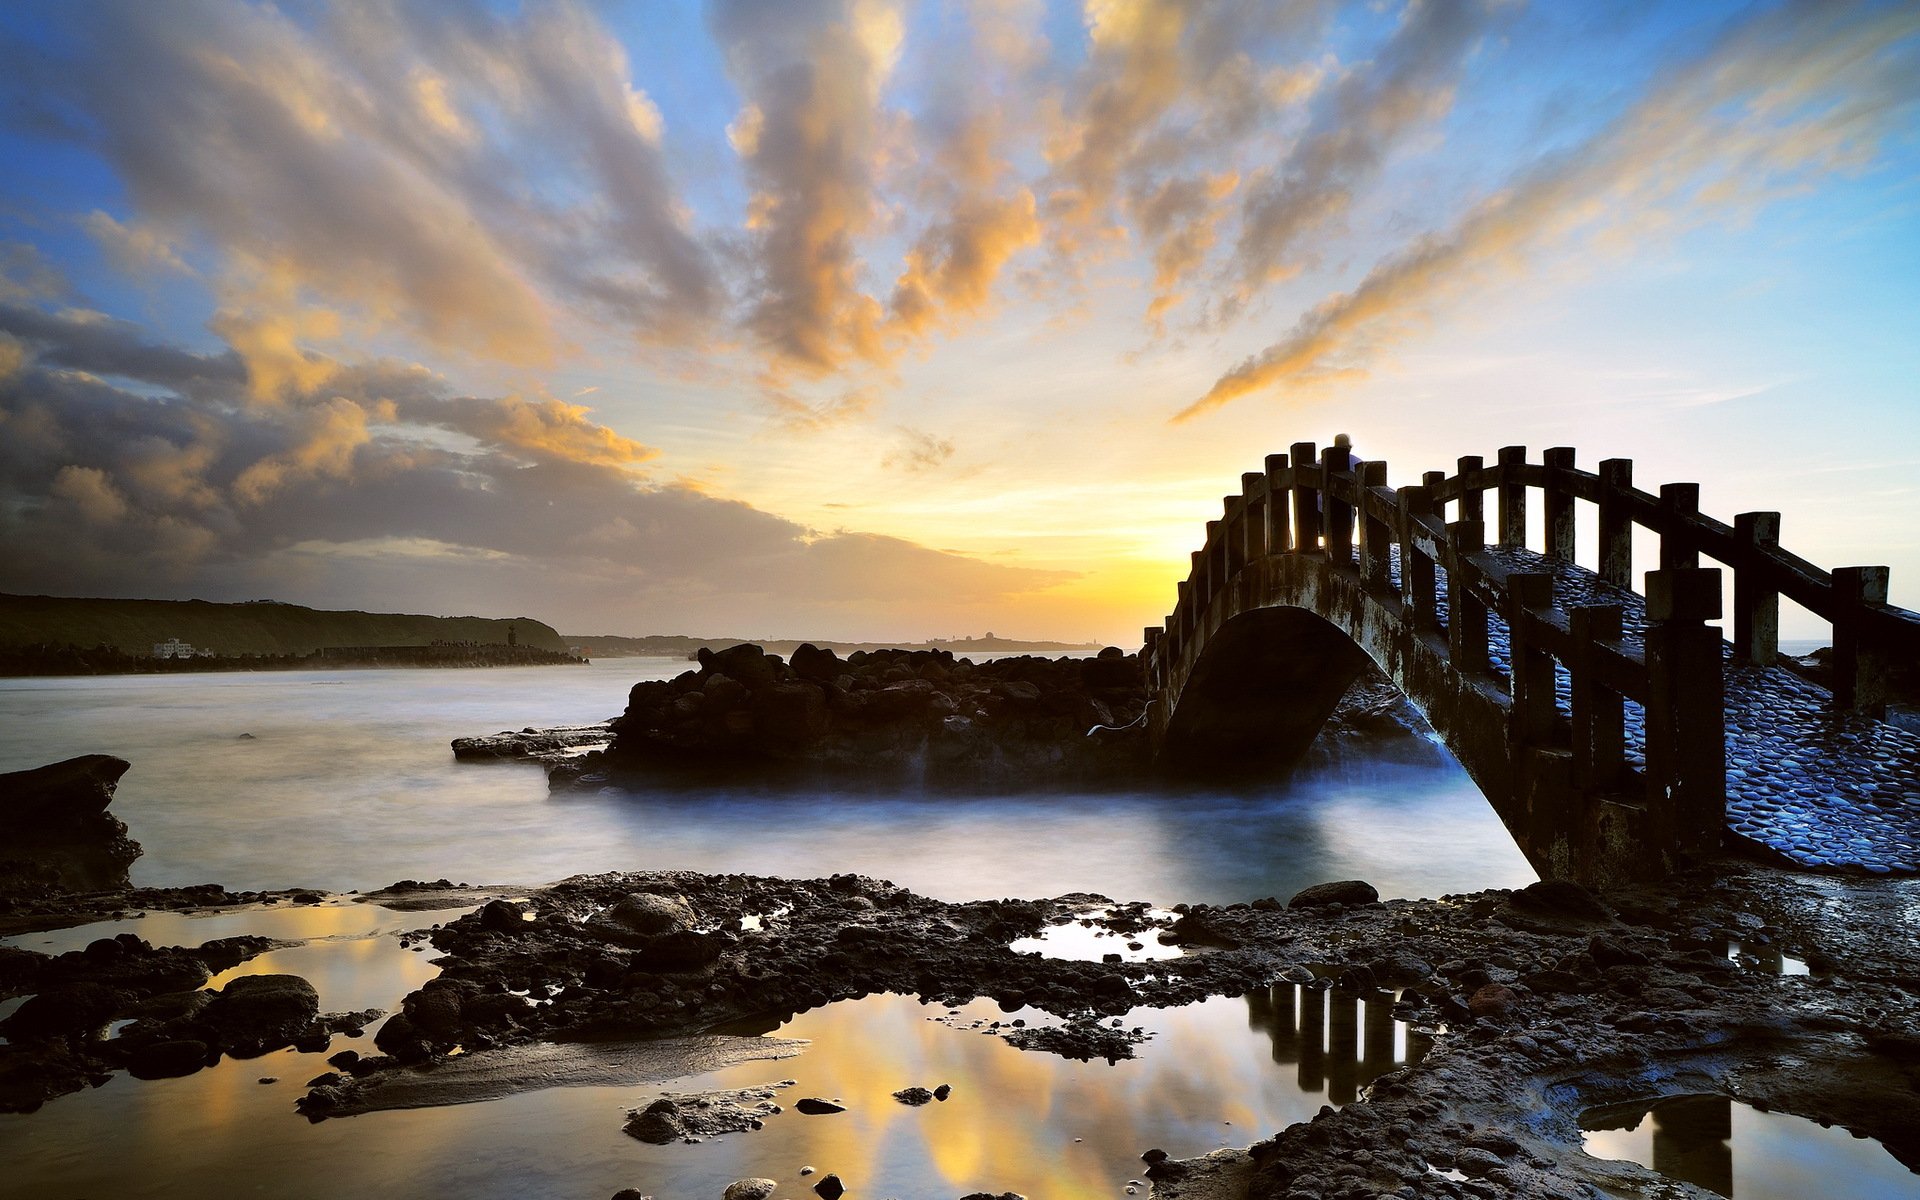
left=0, top=755, right=140, bottom=899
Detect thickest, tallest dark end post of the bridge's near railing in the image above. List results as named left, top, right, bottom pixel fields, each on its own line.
left=1645, top=566, right=1726, bottom=856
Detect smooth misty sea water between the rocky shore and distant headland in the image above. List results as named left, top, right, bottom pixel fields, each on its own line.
left=0, top=659, right=1534, bottom=902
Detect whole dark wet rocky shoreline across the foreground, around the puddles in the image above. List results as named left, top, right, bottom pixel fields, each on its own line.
left=0, top=733, right=1920, bottom=1200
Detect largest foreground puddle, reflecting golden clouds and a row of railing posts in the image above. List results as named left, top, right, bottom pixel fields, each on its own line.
left=0, top=967, right=1427, bottom=1200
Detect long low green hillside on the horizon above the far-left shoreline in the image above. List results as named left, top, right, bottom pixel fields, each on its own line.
left=0, top=593, right=566, bottom=655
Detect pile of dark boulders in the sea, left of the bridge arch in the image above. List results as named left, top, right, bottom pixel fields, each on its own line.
left=553, top=645, right=1150, bottom=787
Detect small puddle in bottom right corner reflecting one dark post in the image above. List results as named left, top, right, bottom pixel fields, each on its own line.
left=1580, top=1096, right=1920, bottom=1200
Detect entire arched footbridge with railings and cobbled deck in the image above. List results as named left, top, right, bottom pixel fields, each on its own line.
left=1146, top=442, right=1920, bottom=883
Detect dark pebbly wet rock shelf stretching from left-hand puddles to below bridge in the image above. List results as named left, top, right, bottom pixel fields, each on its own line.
left=280, top=862, right=1920, bottom=1200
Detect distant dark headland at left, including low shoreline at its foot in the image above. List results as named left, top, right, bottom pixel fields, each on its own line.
left=0, top=593, right=578, bottom=676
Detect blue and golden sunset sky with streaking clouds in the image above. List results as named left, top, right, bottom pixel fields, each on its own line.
left=0, top=0, right=1920, bottom=645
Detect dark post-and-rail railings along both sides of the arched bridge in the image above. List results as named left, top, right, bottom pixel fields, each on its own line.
left=1146, top=442, right=1920, bottom=837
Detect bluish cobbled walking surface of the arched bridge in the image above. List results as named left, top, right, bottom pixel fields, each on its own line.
left=1392, top=547, right=1920, bottom=874
